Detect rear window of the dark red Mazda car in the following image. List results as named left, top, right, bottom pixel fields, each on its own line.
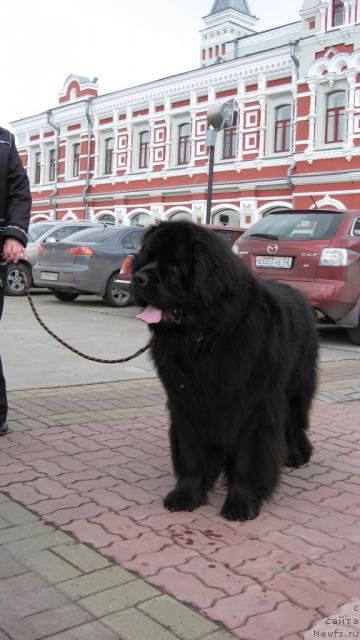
left=242, top=211, right=344, bottom=240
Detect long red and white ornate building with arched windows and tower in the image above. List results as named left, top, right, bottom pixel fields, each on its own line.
left=12, top=0, right=360, bottom=226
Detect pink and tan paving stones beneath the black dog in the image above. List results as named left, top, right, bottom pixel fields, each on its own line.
left=0, top=361, right=360, bottom=640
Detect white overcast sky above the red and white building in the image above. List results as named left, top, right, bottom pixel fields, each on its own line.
left=0, top=0, right=302, bottom=127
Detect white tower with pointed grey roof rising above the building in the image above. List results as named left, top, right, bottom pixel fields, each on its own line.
left=200, top=0, right=257, bottom=67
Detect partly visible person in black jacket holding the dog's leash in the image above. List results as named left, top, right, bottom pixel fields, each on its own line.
left=0, top=128, right=31, bottom=436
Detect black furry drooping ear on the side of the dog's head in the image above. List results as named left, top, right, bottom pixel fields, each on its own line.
left=192, top=241, right=235, bottom=307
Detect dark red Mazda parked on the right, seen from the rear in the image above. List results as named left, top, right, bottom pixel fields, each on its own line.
left=233, top=209, right=360, bottom=345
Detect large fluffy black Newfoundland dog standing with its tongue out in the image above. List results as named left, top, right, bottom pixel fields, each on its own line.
left=133, top=221, right=317, bottom=520
